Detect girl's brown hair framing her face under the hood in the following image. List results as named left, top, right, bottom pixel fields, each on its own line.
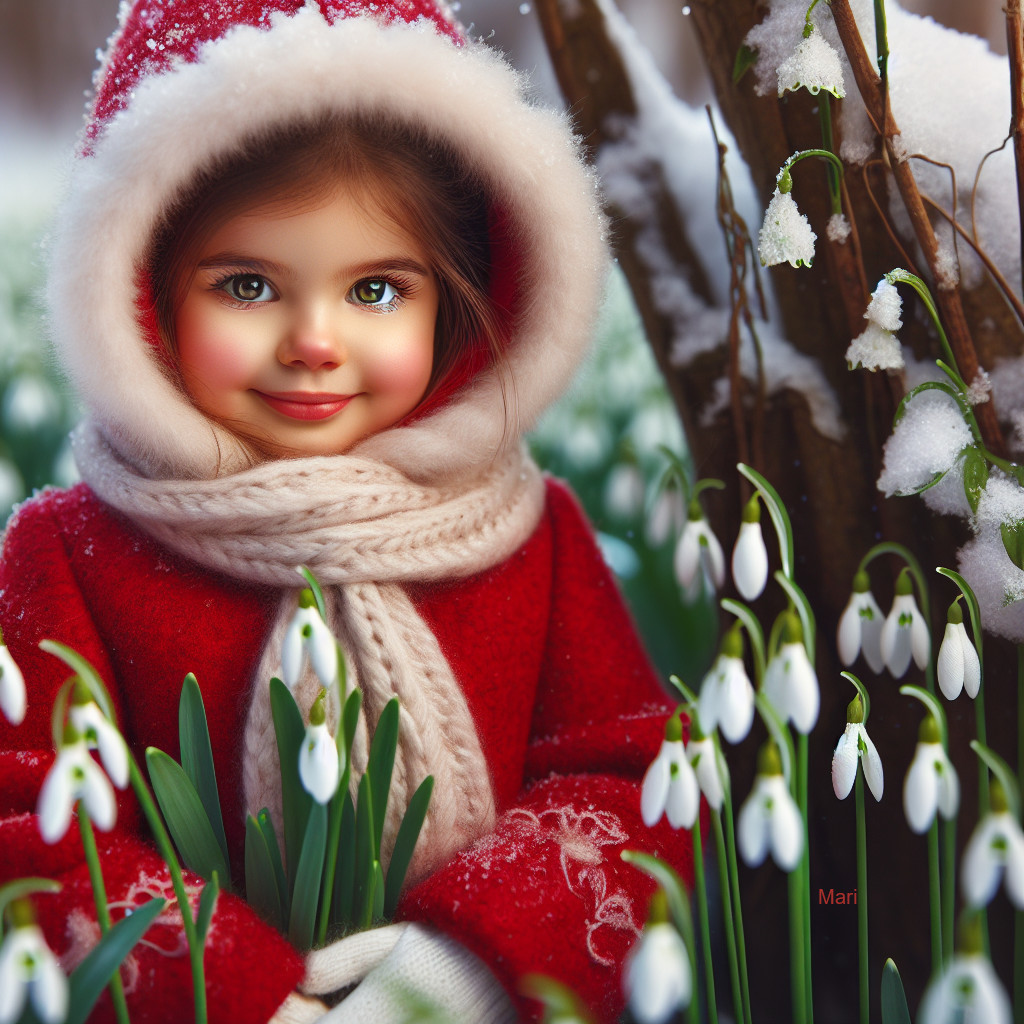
left=146, top=115, right=508, bottom=439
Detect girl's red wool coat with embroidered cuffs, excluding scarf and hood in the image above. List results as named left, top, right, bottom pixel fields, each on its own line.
left=0, top=481, right=690, bottom=1024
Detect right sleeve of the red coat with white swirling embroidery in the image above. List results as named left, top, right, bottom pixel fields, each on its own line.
left=401, top=484, right=692, bottom=1024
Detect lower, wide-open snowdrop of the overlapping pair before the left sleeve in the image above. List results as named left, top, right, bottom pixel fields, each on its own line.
left=37, top=723, right=118, bottom=843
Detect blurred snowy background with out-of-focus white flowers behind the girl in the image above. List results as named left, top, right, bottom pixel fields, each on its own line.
left=0, top=0, right=1006, bottom=683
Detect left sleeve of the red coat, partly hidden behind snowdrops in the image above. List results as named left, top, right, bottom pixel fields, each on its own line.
left=0, top=492, right=303, bottom=1024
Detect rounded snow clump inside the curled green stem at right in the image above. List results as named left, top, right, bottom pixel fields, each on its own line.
left=879, top=391, right=974, bottom=497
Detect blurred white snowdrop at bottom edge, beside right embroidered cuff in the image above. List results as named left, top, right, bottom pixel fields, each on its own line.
left=623, top=890, right=693, bottom=1024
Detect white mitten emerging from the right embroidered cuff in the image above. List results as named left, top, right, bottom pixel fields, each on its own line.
left=321, top=924, right=517, bottom=1024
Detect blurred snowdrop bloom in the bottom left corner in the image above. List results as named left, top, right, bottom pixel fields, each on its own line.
left=0, top=900, right=68, bottom=1024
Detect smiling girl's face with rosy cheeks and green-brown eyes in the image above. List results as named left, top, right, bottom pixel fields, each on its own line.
left=174, top=188, right=438, bottom=458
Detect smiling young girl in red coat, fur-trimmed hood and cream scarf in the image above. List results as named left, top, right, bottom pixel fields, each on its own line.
left=0, top=0, right=681, bottom=1024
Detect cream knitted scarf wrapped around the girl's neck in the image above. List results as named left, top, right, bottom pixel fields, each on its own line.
left=74, top=423, right=544, bottom=882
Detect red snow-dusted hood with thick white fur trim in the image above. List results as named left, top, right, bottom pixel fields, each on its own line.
left=47, top=0, right=606, bottom=483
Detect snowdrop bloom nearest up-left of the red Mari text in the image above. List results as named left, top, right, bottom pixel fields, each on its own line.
left=736, top=741, right=804, bottom=871
